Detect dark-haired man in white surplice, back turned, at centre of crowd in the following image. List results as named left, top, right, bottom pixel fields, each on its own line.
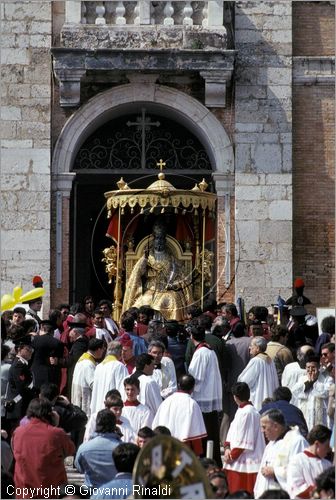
left=152, top=375, right=207, bottom=455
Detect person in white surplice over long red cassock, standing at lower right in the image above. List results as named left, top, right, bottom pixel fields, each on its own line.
left=224, top=382, right=265, bottom=494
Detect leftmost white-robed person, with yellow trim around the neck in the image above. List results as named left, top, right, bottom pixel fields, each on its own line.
left=71, top=339, right=105, bottom=417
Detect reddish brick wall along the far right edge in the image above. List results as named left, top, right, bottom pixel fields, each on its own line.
left=293, top=2, right=335, bottom=307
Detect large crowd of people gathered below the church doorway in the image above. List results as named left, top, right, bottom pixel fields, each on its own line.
left=1, top=286, right=335, bottom=498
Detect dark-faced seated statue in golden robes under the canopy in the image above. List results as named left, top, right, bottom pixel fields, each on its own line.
left=123, top=219, right=193, bottom=321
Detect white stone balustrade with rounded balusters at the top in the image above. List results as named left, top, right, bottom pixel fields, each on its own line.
left=65, top=0, right=224, bottom=29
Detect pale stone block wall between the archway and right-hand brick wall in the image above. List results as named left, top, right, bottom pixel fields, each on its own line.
left=235, top=1, right=292, bottom=307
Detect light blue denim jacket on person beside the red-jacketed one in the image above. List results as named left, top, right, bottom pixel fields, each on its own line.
left=75, top=433, right=121, bottom=487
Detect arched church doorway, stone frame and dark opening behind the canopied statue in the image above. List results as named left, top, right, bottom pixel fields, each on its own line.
left=51, top=84, right=233, bottom=302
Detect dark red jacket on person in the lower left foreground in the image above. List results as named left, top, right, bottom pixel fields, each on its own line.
left=12, top=418, right=76, bottom=498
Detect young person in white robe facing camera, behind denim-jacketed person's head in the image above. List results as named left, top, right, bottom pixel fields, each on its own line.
left=84, top=391, right=137, bottom=443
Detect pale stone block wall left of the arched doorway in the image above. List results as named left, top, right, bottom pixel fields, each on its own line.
left=1, top=0, right=51, bottom=311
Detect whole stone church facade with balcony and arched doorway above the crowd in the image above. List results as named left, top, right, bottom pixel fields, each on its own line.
left=1, top=0, right=335, bottom=309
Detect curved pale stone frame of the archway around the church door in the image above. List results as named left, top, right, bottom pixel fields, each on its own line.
left=52, top=82, right=234, bottom=302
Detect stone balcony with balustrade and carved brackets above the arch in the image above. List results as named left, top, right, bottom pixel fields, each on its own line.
left=52, top=0, right=235, bottom=107
